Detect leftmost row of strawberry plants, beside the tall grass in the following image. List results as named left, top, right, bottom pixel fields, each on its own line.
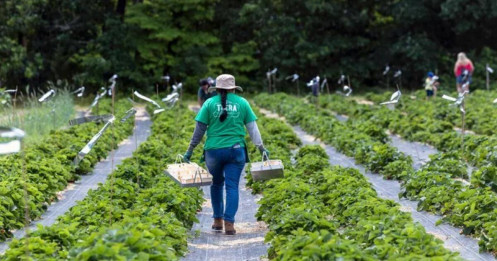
left=0, top=100, right=133, bottom=241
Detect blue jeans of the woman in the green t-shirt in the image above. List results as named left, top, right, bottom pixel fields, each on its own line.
left=205, top=147, right=245, bottom=223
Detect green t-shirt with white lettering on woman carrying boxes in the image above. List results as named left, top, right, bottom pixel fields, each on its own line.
left=195, top=93, right=257, bottom=150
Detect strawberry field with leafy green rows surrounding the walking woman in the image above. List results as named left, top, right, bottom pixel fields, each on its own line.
left=0, top=88, right=497, bottom=260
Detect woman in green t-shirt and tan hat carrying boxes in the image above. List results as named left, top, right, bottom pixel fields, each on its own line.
left=183, top=74, right=269, bottom=235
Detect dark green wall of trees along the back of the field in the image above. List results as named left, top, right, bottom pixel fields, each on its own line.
left=0, top=0, right=497, bottom=91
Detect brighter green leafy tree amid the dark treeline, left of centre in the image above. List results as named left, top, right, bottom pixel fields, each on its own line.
left=125, top=0, right=221, bottom=89
